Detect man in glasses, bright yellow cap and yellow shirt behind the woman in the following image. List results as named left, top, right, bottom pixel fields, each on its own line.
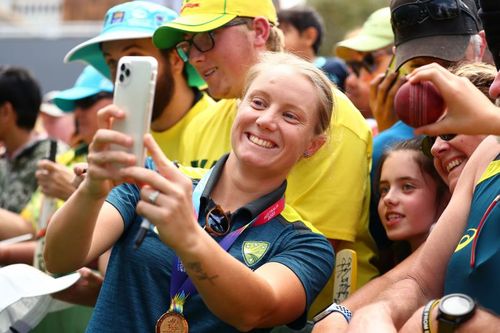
left=153, top=0, right=377, bottom=320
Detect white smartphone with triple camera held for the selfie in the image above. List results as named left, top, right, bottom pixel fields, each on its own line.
left=112, top=56, right=158, bottom=166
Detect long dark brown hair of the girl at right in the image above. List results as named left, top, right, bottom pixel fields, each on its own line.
left=373, top=136, right=449, bottom=205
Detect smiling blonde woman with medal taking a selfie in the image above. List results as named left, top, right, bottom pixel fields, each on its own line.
left=45, top=53, right=334, bottom=332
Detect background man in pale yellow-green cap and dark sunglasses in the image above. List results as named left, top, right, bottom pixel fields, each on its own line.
left=335, top=7, right=394, bottom=127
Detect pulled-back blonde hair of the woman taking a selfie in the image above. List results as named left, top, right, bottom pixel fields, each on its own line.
left=242, top=51, right=334, bottom=134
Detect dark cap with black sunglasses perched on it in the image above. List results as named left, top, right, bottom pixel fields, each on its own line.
left=390, top=0, right=481, bottom=68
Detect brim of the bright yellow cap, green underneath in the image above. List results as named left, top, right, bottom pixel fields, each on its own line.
left=153, top=14, right=236, bottom=49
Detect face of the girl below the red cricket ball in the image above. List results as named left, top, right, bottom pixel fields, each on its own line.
left=378, top=150, right=440, bottom=249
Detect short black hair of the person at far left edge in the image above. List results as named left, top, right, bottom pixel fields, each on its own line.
left=0, top=66, right=42, bottom=130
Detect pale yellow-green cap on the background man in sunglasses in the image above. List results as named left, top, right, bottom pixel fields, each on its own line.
left=335, top=7, right=394, bottom=60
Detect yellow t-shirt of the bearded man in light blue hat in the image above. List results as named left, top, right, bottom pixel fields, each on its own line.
left=151, top=93, right=215, bottom=161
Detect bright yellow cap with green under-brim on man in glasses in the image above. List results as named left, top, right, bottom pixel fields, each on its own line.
left=153, top=0, right=278, bottom=48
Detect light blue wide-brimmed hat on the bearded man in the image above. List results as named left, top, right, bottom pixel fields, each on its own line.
left=64, top=1, right=205, bottom=87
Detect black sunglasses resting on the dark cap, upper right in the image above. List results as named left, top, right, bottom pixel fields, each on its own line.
left=391, top=0, right=460, bottom=29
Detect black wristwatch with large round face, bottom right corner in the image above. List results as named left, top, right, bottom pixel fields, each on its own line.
left=437, top=294, right=476, bottom=333
